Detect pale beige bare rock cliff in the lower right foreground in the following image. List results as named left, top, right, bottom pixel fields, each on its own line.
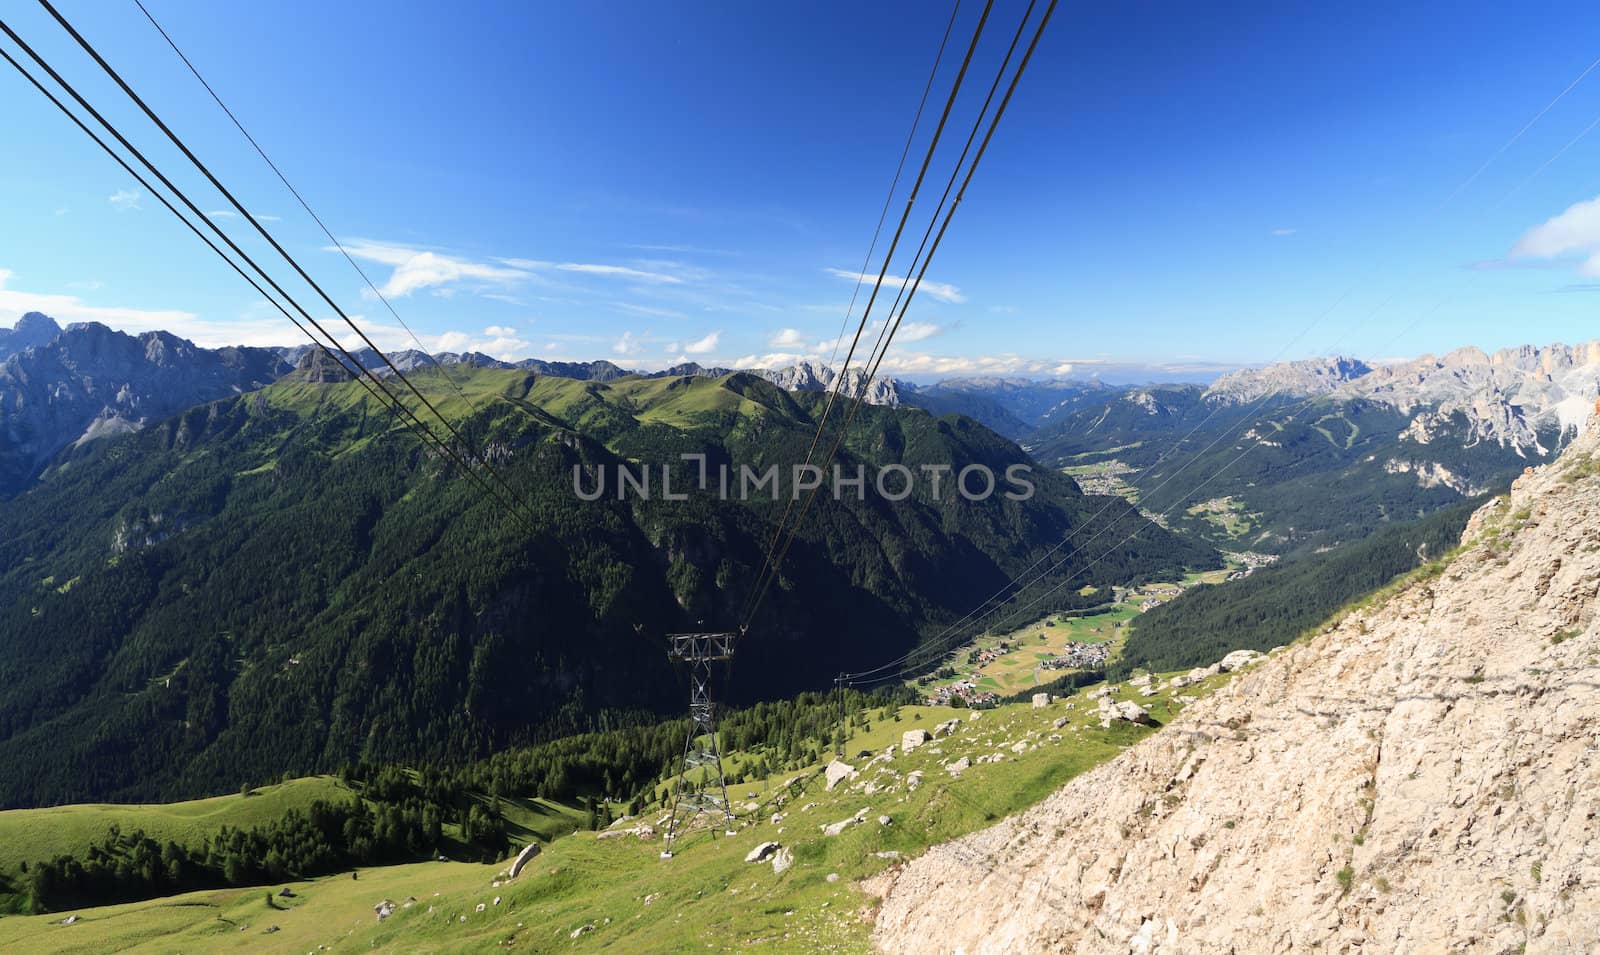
left=874, top=418, right=1600, bottom=953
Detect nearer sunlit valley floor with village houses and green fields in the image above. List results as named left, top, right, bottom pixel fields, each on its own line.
left=915, top=552, right=1277, bottom=709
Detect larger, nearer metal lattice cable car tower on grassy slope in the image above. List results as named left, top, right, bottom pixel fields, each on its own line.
left=661, top=630, right=742, bottom=859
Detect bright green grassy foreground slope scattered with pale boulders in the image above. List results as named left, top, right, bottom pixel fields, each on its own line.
left=0, top=665, right=1227, bottom=953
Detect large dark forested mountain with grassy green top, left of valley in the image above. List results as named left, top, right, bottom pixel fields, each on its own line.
left=0, top=368, right=1218, bottom=806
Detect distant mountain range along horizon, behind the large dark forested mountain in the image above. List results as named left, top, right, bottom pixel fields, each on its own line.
left=0, top=314, right=1600, bottom=552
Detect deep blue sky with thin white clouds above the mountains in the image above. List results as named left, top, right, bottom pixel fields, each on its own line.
left=0, top=0, right=1600, bottom=378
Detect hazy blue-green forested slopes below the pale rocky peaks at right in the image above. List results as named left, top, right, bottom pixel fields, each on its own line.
left=1024, top=386, right=1548, bottom=553
